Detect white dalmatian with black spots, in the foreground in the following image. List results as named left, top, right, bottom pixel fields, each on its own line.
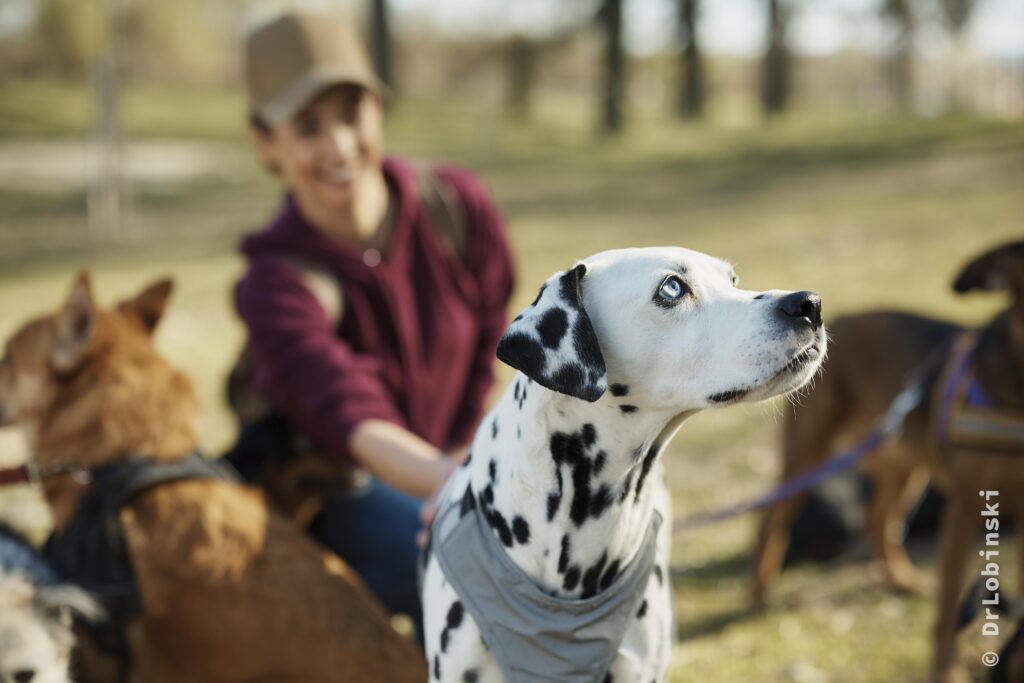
left=422, top=247, right=825, bottom=683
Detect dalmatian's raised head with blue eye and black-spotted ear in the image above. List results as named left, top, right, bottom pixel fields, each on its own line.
left=498, top=247, right=825, bottom=412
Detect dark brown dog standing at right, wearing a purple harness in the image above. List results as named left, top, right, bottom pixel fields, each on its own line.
left=752, top=242, right=1024, bottom=683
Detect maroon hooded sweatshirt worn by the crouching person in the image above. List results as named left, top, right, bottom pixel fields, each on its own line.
left=236, top=159, right=513, bottom=458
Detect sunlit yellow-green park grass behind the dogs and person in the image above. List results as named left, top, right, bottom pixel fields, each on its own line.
left=0, top=78, right=1024, bottom=683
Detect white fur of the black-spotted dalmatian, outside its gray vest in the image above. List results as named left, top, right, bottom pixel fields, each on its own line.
left=423, top=248, right=825, bottom=683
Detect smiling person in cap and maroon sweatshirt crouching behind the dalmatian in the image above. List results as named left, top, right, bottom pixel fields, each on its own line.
left=236, top=13, right=520, bottom=630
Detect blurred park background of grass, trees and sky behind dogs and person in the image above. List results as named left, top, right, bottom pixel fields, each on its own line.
left=0, top=0, right=1024, bottom=683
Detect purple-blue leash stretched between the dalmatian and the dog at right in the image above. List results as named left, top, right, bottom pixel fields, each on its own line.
left=672, top=378, right=925, bottom=533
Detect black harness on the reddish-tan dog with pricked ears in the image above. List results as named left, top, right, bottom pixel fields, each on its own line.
left=43, top=452, right=238, bottom=680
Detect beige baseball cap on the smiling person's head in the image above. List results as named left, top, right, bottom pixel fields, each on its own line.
left=246, top=11, right=386, bottom=125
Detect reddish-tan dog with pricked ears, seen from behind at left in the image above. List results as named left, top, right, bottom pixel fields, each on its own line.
left=0, top=274, right=427, bottom=683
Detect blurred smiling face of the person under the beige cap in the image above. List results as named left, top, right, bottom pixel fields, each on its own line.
left=253, top=84, right=381, bottom=217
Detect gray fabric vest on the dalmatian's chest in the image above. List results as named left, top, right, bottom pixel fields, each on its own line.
left=431, top=483, right=662, bottom=683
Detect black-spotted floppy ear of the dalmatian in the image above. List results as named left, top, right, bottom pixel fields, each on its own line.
left=498, top=263, right=608, bottom=402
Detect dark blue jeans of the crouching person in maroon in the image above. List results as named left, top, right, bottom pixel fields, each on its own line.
left=309, top=480, right=423, bottom=632
